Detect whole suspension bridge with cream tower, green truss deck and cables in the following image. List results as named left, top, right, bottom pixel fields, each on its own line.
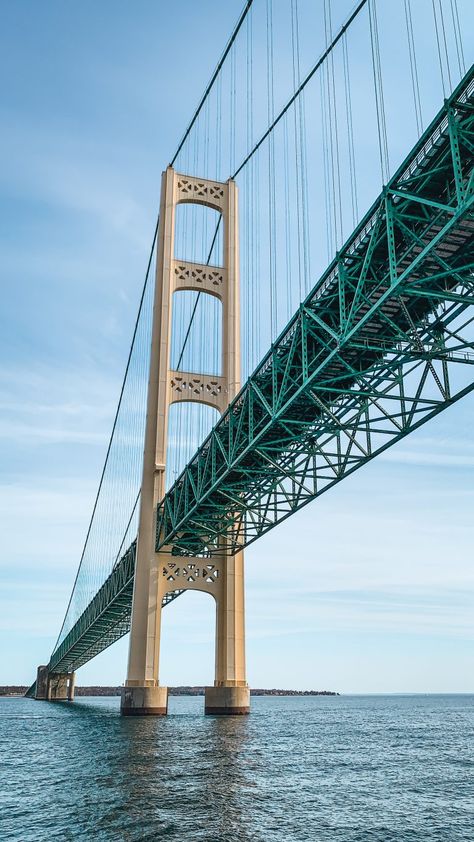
left=27, top=0, right=474, bottom=714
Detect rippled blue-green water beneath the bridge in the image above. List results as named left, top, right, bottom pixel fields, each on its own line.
left=0, top=696, right=474, bottom=842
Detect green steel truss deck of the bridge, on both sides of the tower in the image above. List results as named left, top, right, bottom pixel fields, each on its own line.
left=29, top=68, right=474, bottom=684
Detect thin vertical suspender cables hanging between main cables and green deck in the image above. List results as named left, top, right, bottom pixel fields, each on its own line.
left=54, top=0, right=466, bottom=643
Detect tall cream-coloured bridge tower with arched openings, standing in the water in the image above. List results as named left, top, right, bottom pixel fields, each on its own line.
left=121, top=167, right=250, bottom=715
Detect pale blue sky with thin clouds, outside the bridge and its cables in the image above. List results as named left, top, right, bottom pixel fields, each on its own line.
left=0, top=0, right=474, bottom=693
